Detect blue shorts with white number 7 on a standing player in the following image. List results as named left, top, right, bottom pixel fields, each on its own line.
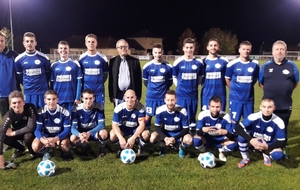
left=229, top=101, right=254, bottom=122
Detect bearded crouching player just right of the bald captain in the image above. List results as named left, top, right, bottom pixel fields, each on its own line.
left=150, top=90, right=193, bottom=158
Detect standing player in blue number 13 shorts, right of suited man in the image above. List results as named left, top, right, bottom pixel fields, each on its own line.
left=143, top=44, right=173, bottom=129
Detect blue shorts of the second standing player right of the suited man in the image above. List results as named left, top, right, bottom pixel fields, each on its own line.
left=177, top=99, right=198, bottom=123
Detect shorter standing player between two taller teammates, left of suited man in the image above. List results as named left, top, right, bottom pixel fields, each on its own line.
left=50, top=41, right=82, bottom=113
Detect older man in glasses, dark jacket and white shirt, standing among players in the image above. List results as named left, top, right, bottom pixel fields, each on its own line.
left=108, top=39, right=142, bottom=106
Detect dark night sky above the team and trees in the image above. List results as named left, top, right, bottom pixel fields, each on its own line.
left=0, top=0, right=300, bottom=52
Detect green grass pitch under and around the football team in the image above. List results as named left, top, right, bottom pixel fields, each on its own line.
left=0, top=62, right=300, bottom=190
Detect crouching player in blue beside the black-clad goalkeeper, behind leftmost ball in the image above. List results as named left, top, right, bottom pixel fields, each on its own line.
left=32, top=90, right=71, bottom=160
